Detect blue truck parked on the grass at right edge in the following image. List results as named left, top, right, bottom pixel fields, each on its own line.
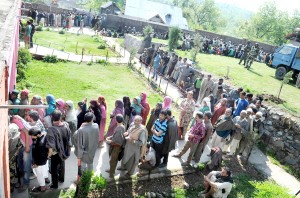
left=269, top=44, right=300, bottom=81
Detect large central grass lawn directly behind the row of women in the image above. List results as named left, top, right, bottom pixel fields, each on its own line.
left=19, top=60, right=178, bottom=129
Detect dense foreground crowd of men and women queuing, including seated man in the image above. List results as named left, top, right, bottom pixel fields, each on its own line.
left=9, top=69, right=266, bottom=195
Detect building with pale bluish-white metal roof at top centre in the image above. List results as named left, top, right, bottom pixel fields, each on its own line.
left=125, top=0, right=188, bottom=30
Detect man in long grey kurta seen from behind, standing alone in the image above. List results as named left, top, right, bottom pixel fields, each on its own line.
left=73, top=112, right=99, bottom=172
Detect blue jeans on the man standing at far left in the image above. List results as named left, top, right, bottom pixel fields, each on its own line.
left=18, top=146, right=32, bottom=185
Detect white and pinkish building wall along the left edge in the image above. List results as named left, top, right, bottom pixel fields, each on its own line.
left=0, top=0, right=21, bottom=198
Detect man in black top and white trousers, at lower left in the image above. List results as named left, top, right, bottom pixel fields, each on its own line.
left=28, top=127, right=48, bottom=192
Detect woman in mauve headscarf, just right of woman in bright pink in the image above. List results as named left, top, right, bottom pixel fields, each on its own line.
left=106, top=100, right=124, bottom=137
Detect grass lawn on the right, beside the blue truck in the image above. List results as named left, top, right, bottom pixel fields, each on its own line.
left=177, top=50, right=300, bottom=117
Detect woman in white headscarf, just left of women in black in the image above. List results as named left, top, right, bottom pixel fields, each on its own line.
left=64, top=100, right=77, bottom=145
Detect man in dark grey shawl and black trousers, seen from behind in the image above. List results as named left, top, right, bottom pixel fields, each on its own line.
left=46, top=110, right=71, bottom=189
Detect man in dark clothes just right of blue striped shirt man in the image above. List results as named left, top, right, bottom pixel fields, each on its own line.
left=158, top=110, right=178, bottom=168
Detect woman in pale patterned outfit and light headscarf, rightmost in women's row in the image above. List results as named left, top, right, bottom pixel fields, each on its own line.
left=179, top=91, right=195, bottom=140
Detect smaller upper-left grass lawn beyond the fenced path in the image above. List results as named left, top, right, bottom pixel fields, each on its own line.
left=33, top=30, right=117, bottom=57
